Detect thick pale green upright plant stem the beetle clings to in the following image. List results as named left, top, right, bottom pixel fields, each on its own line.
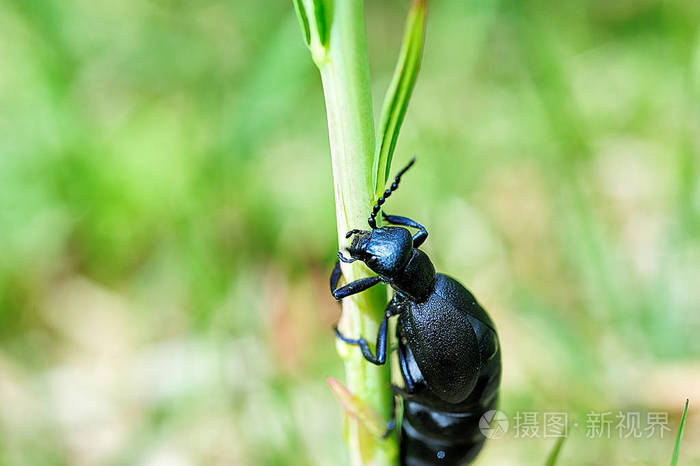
left=312, top=0, right=398, bottom=465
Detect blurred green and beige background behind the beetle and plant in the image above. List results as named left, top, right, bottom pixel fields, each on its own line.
left=0, top=0, right=700, bottom=466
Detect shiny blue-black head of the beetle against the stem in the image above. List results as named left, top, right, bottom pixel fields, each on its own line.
left=348, top=227, right=413, bottom=278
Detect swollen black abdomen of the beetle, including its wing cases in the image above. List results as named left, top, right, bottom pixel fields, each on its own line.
left=397, top=274, right=501, bottom=466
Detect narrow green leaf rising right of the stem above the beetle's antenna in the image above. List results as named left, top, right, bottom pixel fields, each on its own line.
left=372, top=0, right=427, bottom=196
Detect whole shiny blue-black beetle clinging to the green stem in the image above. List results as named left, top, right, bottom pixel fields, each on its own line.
left=330, top=159, right=501, bottom=466
